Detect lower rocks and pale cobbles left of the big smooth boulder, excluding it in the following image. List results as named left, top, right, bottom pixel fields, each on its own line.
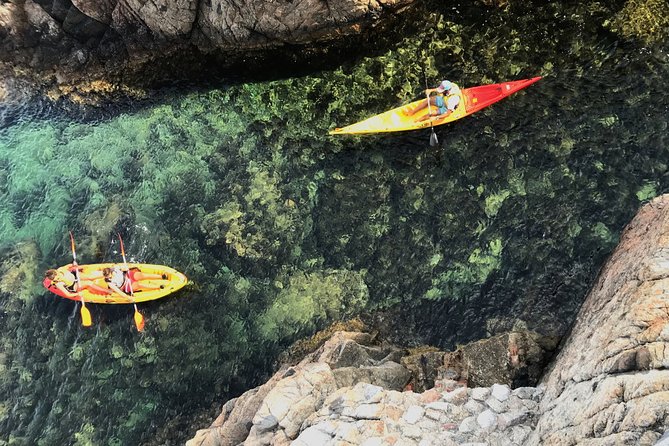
left=188, top=331, right=545, bottom=446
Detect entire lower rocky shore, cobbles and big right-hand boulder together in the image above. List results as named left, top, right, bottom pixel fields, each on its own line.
left=187, top=195, right=669, bottom=446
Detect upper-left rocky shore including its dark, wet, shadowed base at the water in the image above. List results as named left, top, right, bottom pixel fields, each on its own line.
left=0, top=0, right=414, bottom=104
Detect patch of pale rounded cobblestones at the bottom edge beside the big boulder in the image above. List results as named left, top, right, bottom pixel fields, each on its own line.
left=291, top=380, right=541, bottom=446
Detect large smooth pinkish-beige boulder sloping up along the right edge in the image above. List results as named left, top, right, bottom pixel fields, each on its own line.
left=532, top=195, right=669, bottom=446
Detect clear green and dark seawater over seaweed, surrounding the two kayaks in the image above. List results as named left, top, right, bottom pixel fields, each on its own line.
left=0, top=3, right=669, bottom=445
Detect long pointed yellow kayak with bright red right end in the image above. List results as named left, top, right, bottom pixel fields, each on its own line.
left=330, top=76, right=541, bottom=135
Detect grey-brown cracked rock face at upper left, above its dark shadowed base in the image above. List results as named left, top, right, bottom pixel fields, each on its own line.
left=0, top=0, right=414, bottom=96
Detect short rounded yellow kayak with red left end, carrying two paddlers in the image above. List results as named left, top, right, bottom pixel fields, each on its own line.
left=43, top=263, right=188, bottom=304
